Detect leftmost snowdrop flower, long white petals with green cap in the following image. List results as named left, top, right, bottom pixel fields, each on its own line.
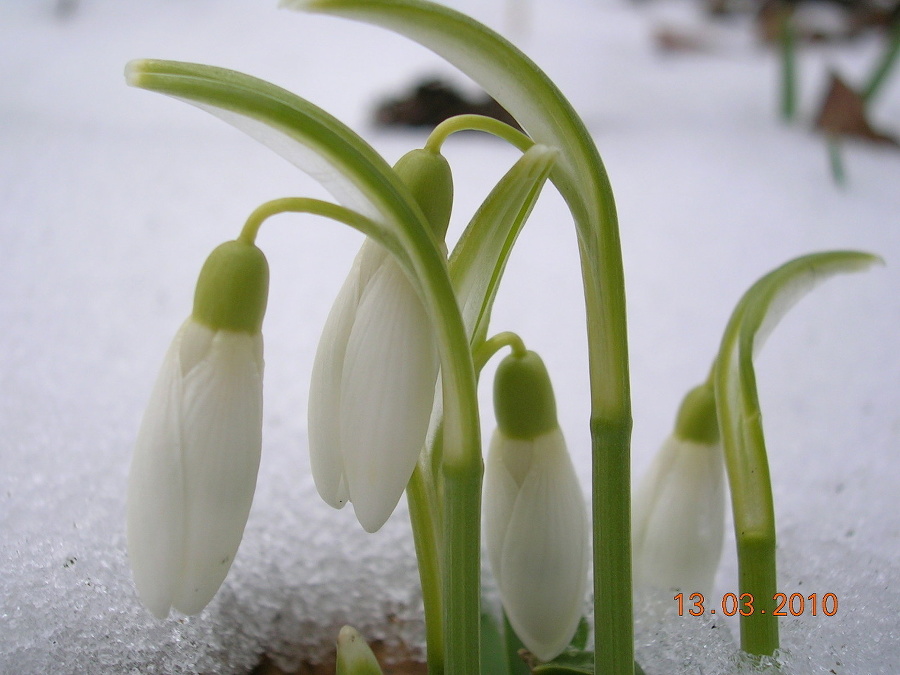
left=127, top=240, right=268, bottom=618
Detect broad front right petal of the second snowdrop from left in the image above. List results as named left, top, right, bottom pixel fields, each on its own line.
left=340, top=257, right=438, bottom=532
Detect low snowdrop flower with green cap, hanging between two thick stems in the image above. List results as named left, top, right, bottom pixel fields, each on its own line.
left=484, top=352, right=590, bottom=661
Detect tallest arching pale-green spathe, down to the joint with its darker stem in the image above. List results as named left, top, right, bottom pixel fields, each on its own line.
left=281, top=0, right=628, bottom=413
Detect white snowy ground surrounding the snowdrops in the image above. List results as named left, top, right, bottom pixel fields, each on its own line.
left=0, top=0, right=900, bottom=675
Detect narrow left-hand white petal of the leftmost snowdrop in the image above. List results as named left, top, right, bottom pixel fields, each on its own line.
left=126, top=322, right=190, bottom=618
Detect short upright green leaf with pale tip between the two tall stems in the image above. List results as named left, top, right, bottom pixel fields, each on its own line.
left=450, top=145, right=558, bottom=349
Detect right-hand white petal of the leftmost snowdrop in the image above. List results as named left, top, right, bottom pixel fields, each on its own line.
left=172, top=328, right=263, bottom=614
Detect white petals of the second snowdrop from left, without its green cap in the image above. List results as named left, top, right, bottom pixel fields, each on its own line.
left=309, top=239, right=439, bottom=532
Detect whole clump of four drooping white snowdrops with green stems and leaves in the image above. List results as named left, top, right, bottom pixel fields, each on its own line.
left=126, top=0, right=876, bottom=675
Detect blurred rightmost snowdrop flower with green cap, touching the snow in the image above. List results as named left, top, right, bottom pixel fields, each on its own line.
left=632, top=385, right=725, bottom=595
